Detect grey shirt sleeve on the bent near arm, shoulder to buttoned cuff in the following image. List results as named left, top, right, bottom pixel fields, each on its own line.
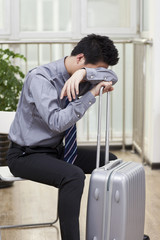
left=30, top=74, right=96, bottom=133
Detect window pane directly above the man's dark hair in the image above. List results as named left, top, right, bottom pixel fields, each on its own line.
left=82, top=0, right=137, bottom=35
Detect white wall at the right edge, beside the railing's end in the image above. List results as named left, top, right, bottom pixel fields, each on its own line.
left=146, top=0, right=160, bottom=164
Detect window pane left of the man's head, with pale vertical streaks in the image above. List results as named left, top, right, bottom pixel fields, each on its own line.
left=20, top=0, right=72, bottom=35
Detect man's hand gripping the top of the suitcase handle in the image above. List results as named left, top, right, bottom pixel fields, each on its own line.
left=90, top=81, right=114, bottom=97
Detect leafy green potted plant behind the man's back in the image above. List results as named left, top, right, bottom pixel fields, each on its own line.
left=0, top=49, right=26, bottom=111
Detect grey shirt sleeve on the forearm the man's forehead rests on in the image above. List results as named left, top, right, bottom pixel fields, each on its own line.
left=84, top=67, right=118, bottom=85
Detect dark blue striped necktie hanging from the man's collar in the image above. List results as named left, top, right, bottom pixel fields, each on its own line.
left=64, top=99, right=77, bottom=164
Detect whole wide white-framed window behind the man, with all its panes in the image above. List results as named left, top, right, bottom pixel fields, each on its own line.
left=0, top=0, right=139, bottom=40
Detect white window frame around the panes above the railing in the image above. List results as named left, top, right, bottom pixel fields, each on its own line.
left=0, top=0, right=142, bottom=40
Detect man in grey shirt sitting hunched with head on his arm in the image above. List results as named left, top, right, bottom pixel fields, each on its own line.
left=8, top=34, right=118, bottom=240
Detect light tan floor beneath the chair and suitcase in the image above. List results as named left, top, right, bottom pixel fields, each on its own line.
left=0, top=151, right=160, bottom=240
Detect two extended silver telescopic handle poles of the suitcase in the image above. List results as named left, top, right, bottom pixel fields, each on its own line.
left=96, top=87, right=110, bottom=168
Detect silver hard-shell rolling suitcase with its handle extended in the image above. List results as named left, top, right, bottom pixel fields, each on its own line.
left=86, top=89, right=145, bottom=240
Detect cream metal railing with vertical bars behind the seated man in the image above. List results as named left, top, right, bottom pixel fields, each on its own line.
left=0, top=39, right=152, bottom=161
